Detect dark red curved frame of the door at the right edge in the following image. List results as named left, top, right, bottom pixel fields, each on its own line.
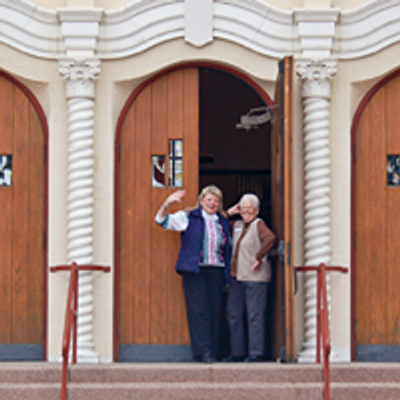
left=350, top=69, right=400, bottom=361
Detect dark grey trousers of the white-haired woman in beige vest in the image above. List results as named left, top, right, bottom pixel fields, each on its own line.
left=227, top=278, right=267, bottom=357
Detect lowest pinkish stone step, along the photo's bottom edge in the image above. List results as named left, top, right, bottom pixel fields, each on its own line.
left=0, top=382, right=400, bottom=400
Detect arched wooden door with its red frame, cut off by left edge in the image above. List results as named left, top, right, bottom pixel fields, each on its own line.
left=0, top=72, right=47, bottom=360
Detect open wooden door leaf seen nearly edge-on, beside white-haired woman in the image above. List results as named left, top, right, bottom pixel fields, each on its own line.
left=271, top=57, right=295, bottom=361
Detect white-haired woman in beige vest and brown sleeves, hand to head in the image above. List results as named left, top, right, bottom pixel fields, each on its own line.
left=224, top=194, right=276, bottom=362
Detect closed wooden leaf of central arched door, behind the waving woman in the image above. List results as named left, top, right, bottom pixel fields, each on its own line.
left=115, top=68, right=199, bottom=361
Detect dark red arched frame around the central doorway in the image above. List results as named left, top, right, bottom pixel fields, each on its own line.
left=113, top=62, right=274, bottom=361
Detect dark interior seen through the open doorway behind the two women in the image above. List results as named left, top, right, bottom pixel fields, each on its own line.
left=199, top=68, right=275, bottom=359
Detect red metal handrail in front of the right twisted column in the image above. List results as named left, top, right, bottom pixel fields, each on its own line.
left=296, top=263, right=348, bottom=400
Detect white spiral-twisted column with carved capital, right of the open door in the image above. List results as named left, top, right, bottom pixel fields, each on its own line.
left=296, top=60, right=336, bottom=362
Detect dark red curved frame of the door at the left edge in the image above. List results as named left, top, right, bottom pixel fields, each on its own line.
left=0, top=69, right=49, bottom=360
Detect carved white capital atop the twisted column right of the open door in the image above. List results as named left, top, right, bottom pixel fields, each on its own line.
left=296, top=60, right=337, bottom=98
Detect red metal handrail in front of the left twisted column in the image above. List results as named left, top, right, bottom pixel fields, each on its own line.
left=50, top=262, right=111, bottom=400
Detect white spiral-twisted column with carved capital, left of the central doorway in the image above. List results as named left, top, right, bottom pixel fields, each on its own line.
left=60, top=59, right=100, bottom=362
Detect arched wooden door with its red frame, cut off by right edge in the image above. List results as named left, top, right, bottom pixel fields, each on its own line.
left=352, top=71, right=400, bottom=361
